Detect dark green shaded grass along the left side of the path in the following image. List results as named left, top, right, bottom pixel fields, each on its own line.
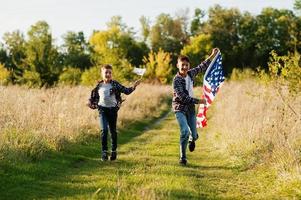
left=0, top=106, right=169, bottom=199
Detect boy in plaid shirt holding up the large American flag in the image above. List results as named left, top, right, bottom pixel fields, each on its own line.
left=172, top=48, right=218, bottom=165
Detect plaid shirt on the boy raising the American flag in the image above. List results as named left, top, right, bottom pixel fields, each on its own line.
left=172, top=60, right=210, bottom=113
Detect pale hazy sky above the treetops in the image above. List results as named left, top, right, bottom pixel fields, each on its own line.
left=0, top=0, right=294, bottom=42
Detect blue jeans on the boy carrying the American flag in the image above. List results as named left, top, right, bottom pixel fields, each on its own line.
left=175, top=110, right=199, bottom=159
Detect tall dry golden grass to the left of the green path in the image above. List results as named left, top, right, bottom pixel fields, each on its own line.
left=0, top=84, right=171, bottom=159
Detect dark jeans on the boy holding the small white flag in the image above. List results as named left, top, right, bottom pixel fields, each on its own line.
left=99, top=107, right=118, bottom=152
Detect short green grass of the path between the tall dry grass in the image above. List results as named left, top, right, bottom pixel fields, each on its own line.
left=0, top=110, right=297, bottom=199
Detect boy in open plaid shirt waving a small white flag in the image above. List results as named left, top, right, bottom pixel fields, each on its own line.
left=88, top=65, right=140, bottom=161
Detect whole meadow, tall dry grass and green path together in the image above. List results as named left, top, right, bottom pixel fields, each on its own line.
left=0, top=78, right=301, bottom=199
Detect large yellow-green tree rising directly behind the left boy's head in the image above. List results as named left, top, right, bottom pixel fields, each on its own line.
left=90, top=17, right=148, bottom=81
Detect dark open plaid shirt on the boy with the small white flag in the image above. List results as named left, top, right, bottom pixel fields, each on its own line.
left=88, top=80, right=135, bottom=109
